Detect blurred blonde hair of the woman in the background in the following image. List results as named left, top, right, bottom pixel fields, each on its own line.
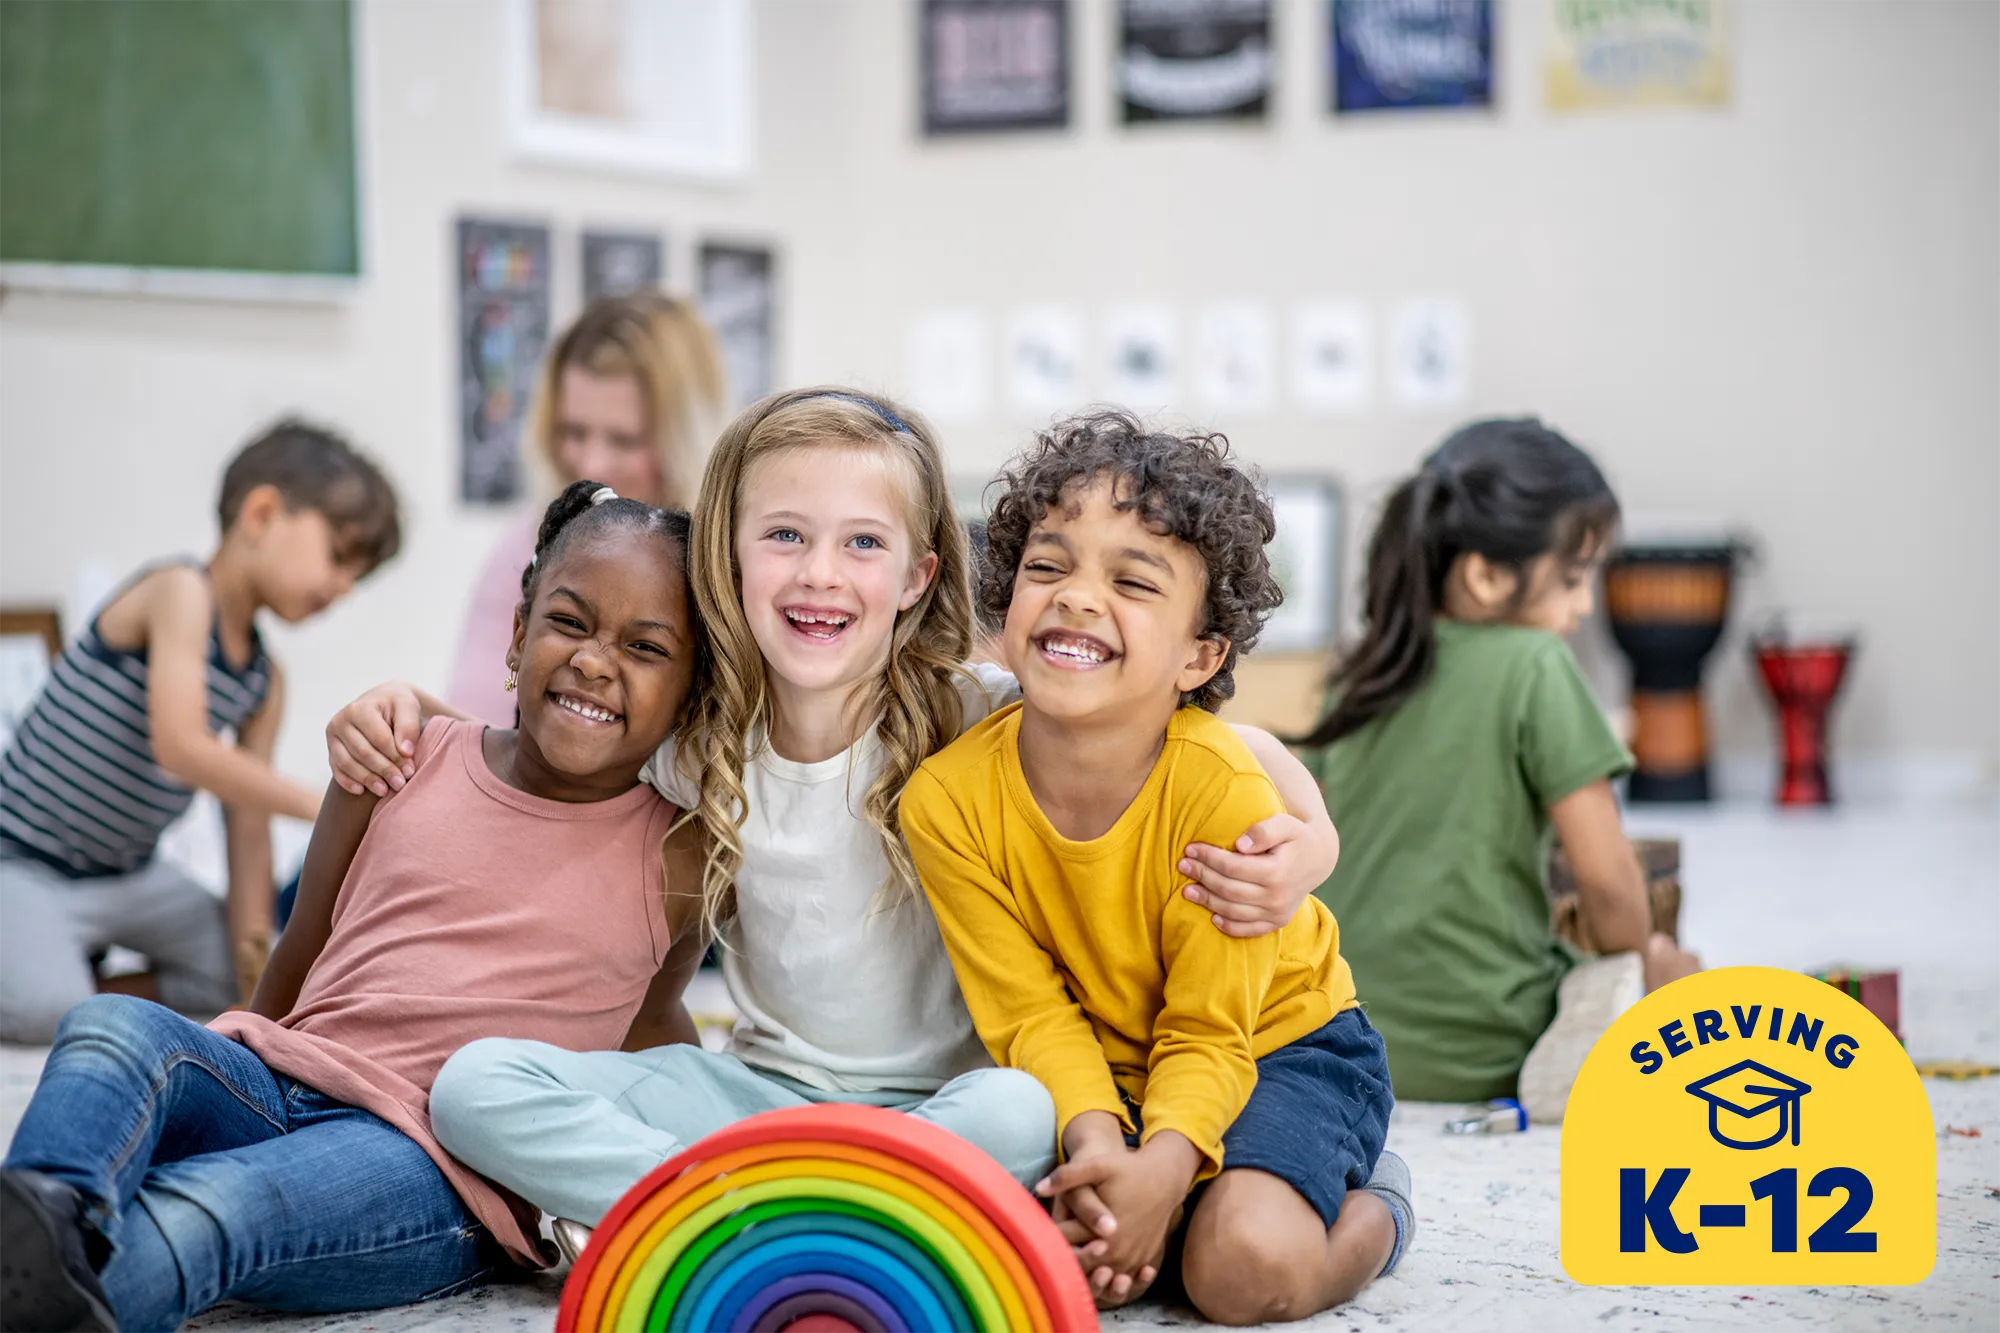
left=528, top=292, right=728, bottom=506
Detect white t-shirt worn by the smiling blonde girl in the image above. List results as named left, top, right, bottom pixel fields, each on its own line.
left=642, top=664, right=1020, bottom=1093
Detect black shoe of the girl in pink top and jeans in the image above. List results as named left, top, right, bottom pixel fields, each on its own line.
left=0, top=1171, right=118, bottom=1333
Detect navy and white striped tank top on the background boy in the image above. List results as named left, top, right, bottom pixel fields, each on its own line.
left=0, top=568, right=270, bottom=879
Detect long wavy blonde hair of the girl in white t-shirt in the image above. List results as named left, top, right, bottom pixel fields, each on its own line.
left=676, top=386, right=972, bottom=929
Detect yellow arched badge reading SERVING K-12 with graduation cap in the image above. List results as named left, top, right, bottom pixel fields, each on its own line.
left=1562, top=967, right=1938, bottom=1287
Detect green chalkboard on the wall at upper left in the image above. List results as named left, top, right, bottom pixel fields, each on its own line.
left=0, top=0, right=360, bottom=280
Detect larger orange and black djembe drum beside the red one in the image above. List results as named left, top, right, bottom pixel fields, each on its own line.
left=1604, top=540, right=1736, bottom=801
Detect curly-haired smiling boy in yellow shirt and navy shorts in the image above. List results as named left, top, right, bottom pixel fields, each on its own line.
left=902, top=412, right=1414, bottom=1323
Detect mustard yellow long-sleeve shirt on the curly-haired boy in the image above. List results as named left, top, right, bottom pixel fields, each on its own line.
left=902, top=705, right=1354, bottom=1179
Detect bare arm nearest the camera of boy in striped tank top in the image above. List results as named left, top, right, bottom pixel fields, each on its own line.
left=134, top=568, right=320, bottom=821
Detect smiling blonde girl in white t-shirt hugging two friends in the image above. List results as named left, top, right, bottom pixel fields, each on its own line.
left=328, top=388, right=1338, bottom=1245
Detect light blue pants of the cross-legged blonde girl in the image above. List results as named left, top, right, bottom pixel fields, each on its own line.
left=430, top=1037, right=1056, bottom=1227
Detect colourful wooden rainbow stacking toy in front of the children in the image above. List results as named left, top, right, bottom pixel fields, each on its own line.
left=556, top=1105, right=1098, bottom=1333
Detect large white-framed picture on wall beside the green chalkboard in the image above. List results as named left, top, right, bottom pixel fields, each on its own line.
left=500, top=0, right=756, bottom=180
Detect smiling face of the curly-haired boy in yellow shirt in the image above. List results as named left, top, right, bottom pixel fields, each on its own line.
left=1002, top=474, right=1226, bottom=725
